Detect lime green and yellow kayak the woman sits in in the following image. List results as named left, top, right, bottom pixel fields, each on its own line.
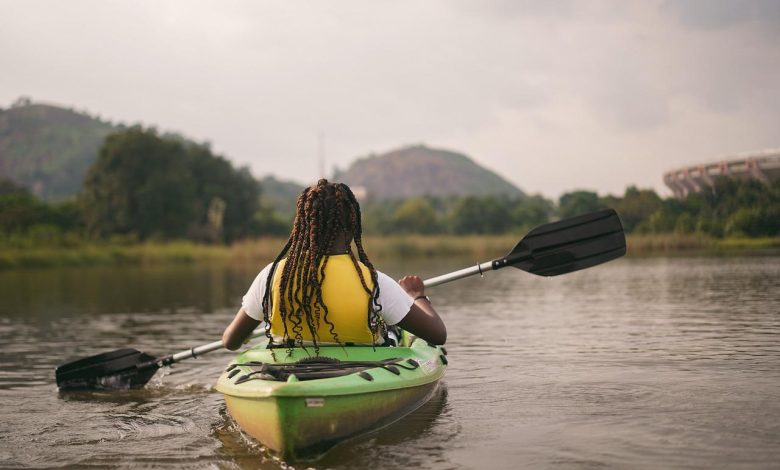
left=216, top=335, right=447, bottom=460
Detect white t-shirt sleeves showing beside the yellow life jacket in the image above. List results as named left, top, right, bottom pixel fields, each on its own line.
left=241, top=263, right=414, bottom=325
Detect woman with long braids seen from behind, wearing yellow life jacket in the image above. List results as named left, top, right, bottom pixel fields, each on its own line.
left=222, top=179, right=447, bottom=353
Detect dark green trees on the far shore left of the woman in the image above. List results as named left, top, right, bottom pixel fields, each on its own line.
left=0, top=127, right=287, bottom=246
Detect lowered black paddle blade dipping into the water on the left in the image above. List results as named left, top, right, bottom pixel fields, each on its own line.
left=55, top=348, right=159, bottom=390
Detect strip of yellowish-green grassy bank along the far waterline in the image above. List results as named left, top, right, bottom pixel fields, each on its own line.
left=0, top=235, right=780, bottom=269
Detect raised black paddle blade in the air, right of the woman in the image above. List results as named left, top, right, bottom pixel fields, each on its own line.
left=493, top=209, right=626, bottom=276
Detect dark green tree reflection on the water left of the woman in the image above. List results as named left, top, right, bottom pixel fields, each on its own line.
left=0, top=265, right=256, bottom=317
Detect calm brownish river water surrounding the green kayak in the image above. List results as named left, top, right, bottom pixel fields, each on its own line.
left=0, top=257, right=780, bottom=469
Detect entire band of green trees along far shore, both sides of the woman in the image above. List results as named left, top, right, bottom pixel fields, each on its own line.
left=0, top=127, right=780, bottom=247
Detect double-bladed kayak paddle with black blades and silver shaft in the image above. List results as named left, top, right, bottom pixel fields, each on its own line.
left=55, top=209, right=626, bottom=390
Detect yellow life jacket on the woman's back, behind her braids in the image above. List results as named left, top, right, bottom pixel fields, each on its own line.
left=271, top=255, right=381, bottom=344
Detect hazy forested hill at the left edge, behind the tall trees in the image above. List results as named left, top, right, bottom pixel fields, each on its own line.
left=0, top=99, right=121, bottom=200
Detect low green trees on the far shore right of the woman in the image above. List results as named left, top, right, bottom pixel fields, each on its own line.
left=356, top=178, right=780, bottom=238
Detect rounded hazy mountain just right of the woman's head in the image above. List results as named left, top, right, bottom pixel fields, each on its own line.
left=334, top=145, right=523, bottom=199
